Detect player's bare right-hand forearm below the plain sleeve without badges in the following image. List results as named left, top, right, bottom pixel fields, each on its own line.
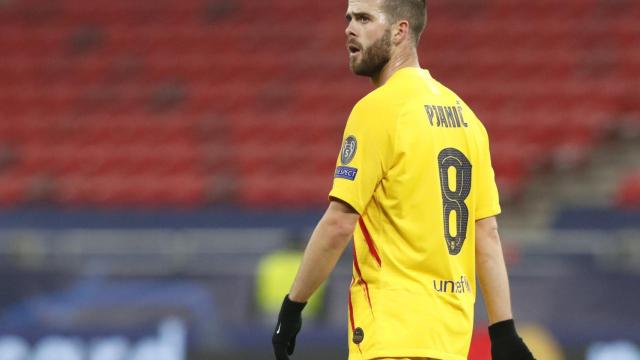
left=476, top=218, right=513, bottom=324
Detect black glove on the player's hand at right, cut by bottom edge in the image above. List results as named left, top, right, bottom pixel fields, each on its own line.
left=489, top=319, right=535, bottom=360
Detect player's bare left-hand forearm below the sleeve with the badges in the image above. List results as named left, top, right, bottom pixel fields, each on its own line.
left=289, top=210, right=352, bottom=302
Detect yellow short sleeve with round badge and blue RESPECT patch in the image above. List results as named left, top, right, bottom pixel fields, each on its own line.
left=329, top=102, right=393, bottom=214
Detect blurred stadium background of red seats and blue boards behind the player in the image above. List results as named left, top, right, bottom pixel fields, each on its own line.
left=0, top=0, right=640, bottom=360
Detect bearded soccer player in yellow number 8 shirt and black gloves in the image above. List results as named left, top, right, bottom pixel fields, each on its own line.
left=272, top=0, right=533, bottom=360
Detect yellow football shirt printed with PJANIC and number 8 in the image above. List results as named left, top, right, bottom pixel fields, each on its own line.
left=330, top=68, right=500, bottom=360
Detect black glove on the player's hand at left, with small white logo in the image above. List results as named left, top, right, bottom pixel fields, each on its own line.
left=271, top=295, right=307, bottom=360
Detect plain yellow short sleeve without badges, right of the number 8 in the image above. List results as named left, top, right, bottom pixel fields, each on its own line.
left=476, top=125, right=501, bottom=220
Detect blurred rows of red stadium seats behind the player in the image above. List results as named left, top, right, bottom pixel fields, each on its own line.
left=0, top=0, right=640, bottom=208
